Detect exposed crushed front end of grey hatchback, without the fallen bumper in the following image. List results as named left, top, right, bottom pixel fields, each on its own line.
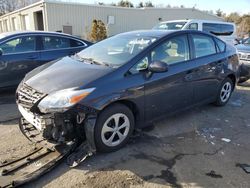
left=16, top=83, right=96, bottom=151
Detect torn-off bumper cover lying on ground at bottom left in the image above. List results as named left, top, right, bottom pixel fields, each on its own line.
left=0, top=144, right=76, bottom=187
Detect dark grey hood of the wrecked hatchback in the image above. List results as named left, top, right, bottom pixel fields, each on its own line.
left=24, top=57, right=113, bottom=94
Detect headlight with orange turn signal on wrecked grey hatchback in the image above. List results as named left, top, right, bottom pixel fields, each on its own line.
left=38, top=88, right=95, bottom=113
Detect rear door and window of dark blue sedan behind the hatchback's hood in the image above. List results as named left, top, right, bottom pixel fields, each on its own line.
left=39, top=35, right=86, bottom=63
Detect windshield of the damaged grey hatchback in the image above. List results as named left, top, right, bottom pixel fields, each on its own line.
left=76, top=34, right=156, bottom=68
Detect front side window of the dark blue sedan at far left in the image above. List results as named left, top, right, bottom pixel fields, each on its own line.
left=0, top=36, right=36, bottom=54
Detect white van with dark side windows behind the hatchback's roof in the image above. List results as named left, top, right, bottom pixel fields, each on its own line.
left=153, top=19, right=237, bottom=45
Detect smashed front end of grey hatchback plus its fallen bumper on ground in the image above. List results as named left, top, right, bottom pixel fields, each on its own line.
left=0, top=83, right=96, bottom=187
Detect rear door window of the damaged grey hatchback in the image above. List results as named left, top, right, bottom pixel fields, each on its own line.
left=192, top=35, right=216, bottom=58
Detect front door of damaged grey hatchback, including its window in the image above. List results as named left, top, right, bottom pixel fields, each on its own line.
left=145, top=35, right=193, bottom=121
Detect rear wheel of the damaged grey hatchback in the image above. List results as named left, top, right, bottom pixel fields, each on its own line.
left=215, top=78, right=234, bottom=106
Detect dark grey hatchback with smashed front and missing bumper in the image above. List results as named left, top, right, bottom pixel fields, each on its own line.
left=17, top=30, right=239, bottom=152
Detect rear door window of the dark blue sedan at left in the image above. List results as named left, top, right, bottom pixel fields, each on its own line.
left=42, top=36, right=70, bottom=50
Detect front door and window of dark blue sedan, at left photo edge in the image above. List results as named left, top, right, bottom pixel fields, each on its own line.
left=0, top=35, right=40, bottom=87
